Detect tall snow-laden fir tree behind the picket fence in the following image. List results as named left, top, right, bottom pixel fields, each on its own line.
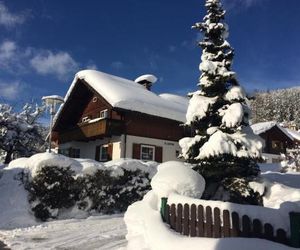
left=180, top=0, right=262, bottom=204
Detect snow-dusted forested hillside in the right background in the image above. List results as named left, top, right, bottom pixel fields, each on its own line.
left=251, top=87, right=300, bottom=129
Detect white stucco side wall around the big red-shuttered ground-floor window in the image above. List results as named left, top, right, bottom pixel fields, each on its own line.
left=126, top=135, right=181, bottom=162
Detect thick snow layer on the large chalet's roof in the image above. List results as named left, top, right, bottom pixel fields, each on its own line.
left=56, top=70, right=188, bottom=122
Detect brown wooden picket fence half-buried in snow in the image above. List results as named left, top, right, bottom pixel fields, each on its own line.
left=161, top=204, right=290, bottom=245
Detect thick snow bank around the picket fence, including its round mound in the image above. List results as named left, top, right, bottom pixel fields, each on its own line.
left=124, top=163, right=300, bottom=250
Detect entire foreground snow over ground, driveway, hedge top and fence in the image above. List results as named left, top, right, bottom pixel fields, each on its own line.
left=0, top=154, right=300, bottom=250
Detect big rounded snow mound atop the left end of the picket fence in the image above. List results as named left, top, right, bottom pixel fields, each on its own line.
left=151, top=161, right=205, bottom=198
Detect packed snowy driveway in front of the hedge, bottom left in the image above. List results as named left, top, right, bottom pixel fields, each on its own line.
left=0, top=215, right=127, bottom=250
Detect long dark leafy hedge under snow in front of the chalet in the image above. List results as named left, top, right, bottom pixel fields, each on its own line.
left=25, top=160, right=150, bottom=221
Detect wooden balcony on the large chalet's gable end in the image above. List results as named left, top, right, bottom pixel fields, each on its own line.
left=58, top=119, right=124, bottom=143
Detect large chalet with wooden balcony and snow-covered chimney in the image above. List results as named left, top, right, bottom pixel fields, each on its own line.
left=53, top=70, right=188, bottom=162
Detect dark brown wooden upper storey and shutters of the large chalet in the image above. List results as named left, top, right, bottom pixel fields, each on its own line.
left=53, top=80, right=184, bottom=162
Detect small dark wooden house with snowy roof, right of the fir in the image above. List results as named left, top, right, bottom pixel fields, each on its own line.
left=251, top=121, right=300, bottom=163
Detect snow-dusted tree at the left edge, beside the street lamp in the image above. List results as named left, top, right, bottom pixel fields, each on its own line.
left=0, top=104, right=46, bottom=163
